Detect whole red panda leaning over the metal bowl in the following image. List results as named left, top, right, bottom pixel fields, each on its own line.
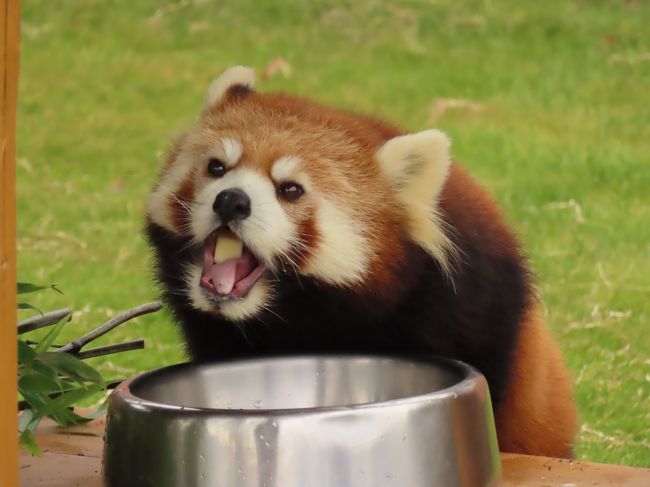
left=147, top=66, right=577, bottom=457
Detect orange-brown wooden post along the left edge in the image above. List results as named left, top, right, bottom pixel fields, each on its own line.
left=0, top=0, right=20, bottom=487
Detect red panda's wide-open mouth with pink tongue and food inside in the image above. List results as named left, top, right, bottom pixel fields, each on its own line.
left=201, top=228, right=266, bottom=298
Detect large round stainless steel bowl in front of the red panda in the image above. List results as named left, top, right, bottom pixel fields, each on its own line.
left=104, top=355, right=499, bottom=487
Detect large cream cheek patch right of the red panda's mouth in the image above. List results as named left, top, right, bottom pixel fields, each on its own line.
left=304, top=199, right=370, bottom=285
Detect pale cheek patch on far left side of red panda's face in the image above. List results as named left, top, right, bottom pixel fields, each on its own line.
left=147, top=154, right=193, bottom=232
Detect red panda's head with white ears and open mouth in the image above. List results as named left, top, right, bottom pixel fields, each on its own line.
left=148, top=68, right=448, bottom=320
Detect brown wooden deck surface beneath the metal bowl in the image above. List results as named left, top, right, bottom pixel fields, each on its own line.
left=20, top=419, right=650, bottom=487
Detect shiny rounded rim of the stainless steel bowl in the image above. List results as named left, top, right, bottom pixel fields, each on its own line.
left=109, top=353, right=489, bottom=417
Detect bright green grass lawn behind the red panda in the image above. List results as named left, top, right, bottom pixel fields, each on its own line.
left=17, top=0, right=650, bottom=466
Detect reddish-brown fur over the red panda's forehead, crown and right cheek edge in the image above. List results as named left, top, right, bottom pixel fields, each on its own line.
left=198, top=92, right=405, bottom=292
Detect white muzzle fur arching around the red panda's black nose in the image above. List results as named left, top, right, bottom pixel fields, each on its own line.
left=191, top=168, right=296, bottom=264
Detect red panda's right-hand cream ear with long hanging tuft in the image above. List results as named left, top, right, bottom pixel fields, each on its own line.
left=376, top=130, right=455, bottom=273
